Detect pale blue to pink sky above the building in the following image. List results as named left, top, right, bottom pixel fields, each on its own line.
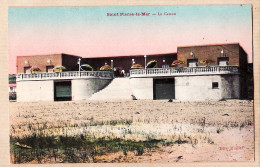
left=8, top=5, right=252, bottom=73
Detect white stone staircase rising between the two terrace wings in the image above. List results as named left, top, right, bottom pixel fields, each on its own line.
left=89, top=78, right=132, bottom=100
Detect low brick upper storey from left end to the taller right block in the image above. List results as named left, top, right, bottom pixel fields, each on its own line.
left=17, top=53, right=177, bottom=74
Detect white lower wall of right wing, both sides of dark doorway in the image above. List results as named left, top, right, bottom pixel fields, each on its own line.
left=130, top=75, right=221, bottom=101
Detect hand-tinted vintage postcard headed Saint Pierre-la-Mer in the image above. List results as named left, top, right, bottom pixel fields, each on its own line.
left=8, top=5, right=255, bottom=164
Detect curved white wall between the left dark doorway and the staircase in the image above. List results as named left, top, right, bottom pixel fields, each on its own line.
left=71, top=78, right=112, bottom=100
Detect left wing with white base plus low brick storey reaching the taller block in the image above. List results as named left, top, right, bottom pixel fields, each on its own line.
left=14, top=53, right=177, bottom=101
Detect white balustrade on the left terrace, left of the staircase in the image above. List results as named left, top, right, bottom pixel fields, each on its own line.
left=16, top=71, right=114, bottom=81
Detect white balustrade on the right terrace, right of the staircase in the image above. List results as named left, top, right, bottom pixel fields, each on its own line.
left=130, top=66, right=239, bottom=77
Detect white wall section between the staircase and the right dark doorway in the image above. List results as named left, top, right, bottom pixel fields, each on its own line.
left=130, top=78, right=153, bottom=99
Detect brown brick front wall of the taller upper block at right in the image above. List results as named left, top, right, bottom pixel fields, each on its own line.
left=177, top=43, right=240, bottom=67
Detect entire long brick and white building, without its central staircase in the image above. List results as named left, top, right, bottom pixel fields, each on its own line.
left=14, top=43, right=252, bottom=101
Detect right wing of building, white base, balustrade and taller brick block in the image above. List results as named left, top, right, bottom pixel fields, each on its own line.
left=130, top=43, right=248, bottom=101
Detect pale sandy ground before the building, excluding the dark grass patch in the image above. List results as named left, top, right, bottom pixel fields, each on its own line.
left=9, top=100, right=254, bottom=162
